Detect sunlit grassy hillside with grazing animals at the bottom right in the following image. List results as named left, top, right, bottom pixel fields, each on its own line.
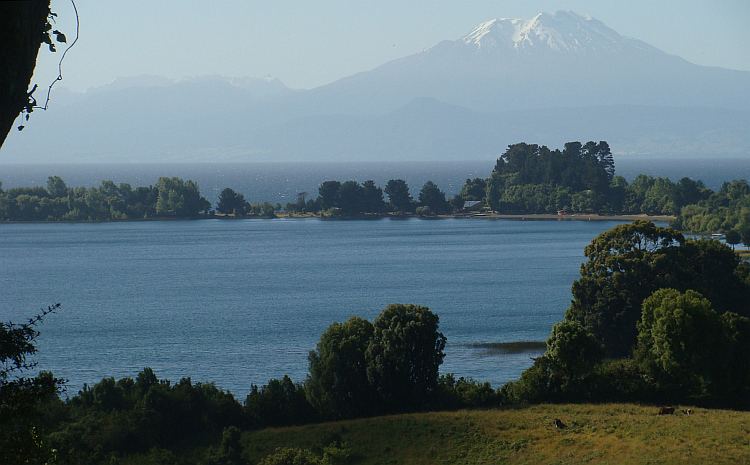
left=242, top=404, right=750, bottom=465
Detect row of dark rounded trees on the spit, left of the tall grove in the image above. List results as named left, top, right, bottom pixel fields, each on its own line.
left=284, top=179, right=452, bottom=217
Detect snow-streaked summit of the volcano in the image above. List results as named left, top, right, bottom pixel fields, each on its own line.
left=460, top=11, right=655, bottom=53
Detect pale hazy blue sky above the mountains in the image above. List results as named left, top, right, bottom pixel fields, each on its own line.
left=34, top=0, right=750, bottom=92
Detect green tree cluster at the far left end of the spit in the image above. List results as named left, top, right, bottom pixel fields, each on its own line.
left=0, top=176, right=211, bottom=221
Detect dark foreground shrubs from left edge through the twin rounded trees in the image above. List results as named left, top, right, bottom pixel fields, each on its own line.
left=10, top=304, right=499, bottom=464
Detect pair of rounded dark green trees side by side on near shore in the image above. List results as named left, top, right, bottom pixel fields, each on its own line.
left=307, top=304, right=446, bottom=419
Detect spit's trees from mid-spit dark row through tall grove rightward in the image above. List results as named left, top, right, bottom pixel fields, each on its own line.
left=266, top=141, right=724, bottom=217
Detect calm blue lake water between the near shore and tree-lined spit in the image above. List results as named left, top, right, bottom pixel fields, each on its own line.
left=0, top=219, right=664, bottom=399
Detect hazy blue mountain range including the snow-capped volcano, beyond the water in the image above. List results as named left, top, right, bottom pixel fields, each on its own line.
left=0, top=11, right=750, bottom=162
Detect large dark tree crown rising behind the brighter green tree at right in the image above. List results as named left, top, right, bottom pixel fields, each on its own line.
left=566, top=220, right=750, bottom=357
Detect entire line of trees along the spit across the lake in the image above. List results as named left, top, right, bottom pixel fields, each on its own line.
left=0, top=141, right=750, bottom=237
